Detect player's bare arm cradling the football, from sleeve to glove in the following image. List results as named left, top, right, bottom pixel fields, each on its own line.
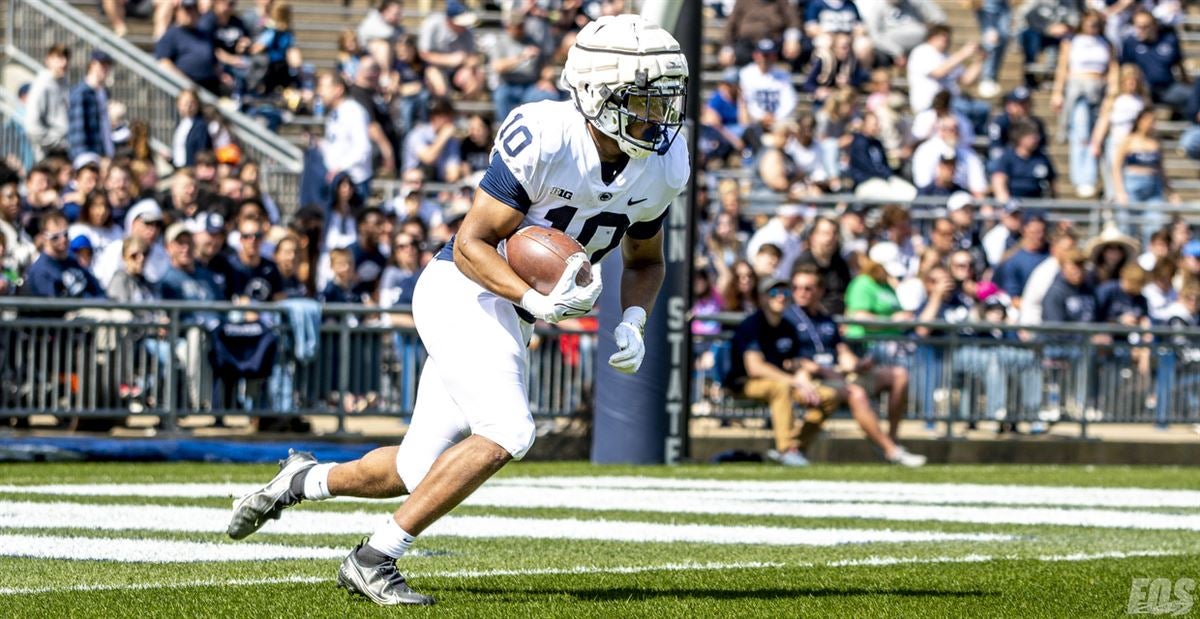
left=454, top=191, right=529, bottom=304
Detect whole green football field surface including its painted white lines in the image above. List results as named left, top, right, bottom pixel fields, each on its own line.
left=0, top=463, right=1200, bottom=618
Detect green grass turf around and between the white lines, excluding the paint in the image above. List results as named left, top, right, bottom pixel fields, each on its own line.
left=0, top=463, right=1200, bottom=617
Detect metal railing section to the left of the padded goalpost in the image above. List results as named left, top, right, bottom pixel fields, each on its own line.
left=0, top=298, right=595, bottom=431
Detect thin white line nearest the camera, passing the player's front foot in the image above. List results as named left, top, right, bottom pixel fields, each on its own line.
left=0, top=551, right=1184, bottom=596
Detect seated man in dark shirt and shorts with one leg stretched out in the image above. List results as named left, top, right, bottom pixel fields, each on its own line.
left=784, top=265, right=925, bottom=467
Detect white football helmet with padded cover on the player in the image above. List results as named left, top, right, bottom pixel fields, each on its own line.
left=562, top=14, right=688, bottom=158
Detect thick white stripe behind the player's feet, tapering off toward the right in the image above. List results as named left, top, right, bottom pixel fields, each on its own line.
left=0, top=501, right=1012, bottom=547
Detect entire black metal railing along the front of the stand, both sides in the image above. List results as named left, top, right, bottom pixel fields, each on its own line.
left=0, top=298, right=1200, bottom=434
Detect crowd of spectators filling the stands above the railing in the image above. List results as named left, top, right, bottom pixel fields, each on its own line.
left=7, top=0, right=1200, bottom=436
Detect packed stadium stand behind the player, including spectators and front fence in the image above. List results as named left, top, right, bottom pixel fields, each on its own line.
left=0, top=0, right=1200, bottom=446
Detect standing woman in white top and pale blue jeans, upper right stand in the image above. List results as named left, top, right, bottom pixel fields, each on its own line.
left=1050, top=11, right=1118, bottom=198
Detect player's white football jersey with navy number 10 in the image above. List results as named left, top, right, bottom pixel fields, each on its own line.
left=439, top=101, right=691, bottom=264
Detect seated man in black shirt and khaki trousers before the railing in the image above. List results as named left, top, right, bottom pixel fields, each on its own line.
left=726, top=277, right=840, bottom=467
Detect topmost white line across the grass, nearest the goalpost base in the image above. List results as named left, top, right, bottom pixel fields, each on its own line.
left=7, top=476, right=1200, bottom=509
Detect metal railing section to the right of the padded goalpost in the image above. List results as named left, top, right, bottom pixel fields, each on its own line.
left=692, top=314, right=1200, bottom=435
